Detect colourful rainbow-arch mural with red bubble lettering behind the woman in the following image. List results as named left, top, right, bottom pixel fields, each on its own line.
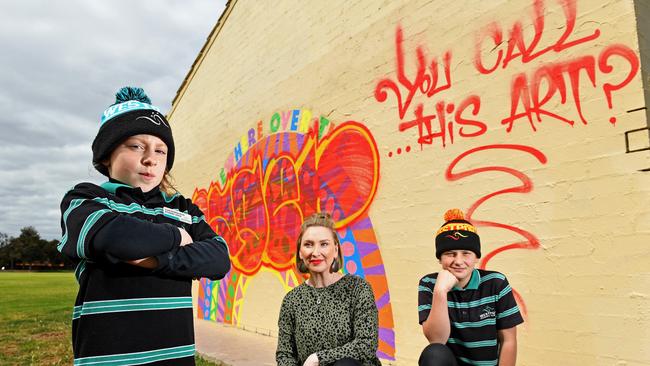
left=192, top=109, right=395, bottom=360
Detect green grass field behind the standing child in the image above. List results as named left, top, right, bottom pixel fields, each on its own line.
left=0, top=271, right=225, bottom=366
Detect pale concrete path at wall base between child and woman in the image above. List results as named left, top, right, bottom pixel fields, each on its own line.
left=194, top=318, right=278, bottom=366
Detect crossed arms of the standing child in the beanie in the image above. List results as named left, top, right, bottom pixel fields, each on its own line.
left=58, top=183, right=230, bottom=279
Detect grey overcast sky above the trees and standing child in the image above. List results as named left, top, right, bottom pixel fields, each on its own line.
left=0, top=0, right=225, bottom=239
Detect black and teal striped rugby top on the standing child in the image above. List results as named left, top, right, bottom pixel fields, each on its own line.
left=58, top=180, right=230, bottom=366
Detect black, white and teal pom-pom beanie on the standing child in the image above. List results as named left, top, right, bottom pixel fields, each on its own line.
left=92, top=86, right=174, bottom=177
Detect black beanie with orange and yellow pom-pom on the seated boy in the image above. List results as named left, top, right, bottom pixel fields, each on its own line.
left=436, top=208, right=481, bottom=259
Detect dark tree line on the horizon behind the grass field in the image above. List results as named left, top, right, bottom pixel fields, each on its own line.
left=0, top=226, right=74, bottom=270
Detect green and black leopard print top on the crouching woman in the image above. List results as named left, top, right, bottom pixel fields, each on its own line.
left=275, top=275, right=381, bottom=366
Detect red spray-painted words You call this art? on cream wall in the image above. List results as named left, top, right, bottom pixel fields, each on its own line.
left=374, top=0, right=639, bottom=152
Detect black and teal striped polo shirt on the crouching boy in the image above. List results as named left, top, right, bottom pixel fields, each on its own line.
left=418, top=269, right=524, bottom=366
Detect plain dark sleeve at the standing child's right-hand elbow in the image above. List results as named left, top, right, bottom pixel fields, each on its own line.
left=156, top=204, right=230, bottom=280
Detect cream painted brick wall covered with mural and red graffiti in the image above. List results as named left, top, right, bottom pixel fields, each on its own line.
left=169, top=0, right=650, bottom=366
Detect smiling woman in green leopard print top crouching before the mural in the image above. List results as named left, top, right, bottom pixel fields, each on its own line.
left=275, top=213, right=381, bottom=366
